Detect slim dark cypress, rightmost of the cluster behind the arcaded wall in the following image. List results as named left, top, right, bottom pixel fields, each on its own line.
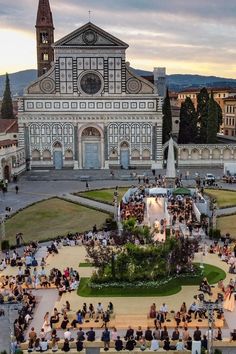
left=206, top=93, right=218, bottom=144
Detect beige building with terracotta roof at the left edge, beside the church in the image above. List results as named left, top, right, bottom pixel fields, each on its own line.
left=0, top=119, right=25, bottom=181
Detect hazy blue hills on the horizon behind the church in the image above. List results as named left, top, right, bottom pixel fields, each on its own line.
left=0, top=69, right=236, bottom=96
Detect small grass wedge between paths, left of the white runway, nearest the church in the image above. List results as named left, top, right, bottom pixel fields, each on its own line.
left=77, top=187, right=129, bottom=204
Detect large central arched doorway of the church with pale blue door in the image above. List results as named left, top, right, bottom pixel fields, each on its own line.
left=81, top=127, right=101, bottom=169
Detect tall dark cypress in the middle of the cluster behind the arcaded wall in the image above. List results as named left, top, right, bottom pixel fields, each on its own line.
left=197, top=87, right=209, bottom=144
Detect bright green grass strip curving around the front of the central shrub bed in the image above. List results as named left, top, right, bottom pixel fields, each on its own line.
left=78, top=264, right=226, bottom=297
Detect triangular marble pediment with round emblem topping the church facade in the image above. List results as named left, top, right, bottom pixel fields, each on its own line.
left=54, top=22, right=128, bottom=48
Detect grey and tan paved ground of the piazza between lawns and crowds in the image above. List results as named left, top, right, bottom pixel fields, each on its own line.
left=0, top=170, right=236, bottom=350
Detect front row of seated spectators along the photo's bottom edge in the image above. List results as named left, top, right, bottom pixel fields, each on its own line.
left=13, top=326, right=236, bottom=352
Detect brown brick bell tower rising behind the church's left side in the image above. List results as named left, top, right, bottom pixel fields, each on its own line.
left=35, top=0, right=54, bottom=77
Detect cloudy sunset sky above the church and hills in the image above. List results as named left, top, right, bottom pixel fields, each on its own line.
left=0, top=0, right=236, bottom=78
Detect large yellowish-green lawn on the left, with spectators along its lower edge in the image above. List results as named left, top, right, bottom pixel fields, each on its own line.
left=5, top=198, right=108, bottom=244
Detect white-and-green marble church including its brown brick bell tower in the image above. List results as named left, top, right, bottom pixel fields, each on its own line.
left=18, top=0, right=165, bottom=169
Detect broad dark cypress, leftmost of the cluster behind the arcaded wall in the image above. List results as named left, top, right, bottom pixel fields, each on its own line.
left=178, top=97, right=197, bottom=144
